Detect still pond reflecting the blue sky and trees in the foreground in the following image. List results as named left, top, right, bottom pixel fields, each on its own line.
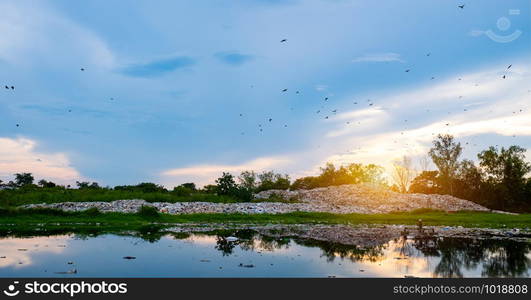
left=0, top=230, right=531, bottom=277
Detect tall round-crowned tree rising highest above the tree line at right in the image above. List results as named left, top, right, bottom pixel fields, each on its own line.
left=429, top=134, right=463, bottom=194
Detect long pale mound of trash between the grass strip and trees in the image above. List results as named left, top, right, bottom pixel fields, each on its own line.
left=23, top=184, right=489, bottom=214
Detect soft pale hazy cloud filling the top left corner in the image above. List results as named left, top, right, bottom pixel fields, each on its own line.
left=0, top=1, right=114, bottom=68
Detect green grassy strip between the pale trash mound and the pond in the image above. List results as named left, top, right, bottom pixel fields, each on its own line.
left=0, top=209, right=531, bottom=230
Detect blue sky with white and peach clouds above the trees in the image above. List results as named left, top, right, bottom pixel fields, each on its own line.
left=0, top=0, right=531, bottom=187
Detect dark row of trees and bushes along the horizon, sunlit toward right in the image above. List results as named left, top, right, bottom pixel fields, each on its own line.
left=0, top=135, right=531, bottom=211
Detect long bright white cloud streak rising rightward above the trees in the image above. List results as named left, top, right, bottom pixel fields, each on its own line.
left=158, top=58, right=531, bottom=183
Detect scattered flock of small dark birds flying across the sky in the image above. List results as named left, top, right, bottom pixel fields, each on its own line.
left=4, top=4, right=523, bottom=162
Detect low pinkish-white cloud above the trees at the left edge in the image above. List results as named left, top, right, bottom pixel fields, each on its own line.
left=0, top=138, right=84, bottom=184
